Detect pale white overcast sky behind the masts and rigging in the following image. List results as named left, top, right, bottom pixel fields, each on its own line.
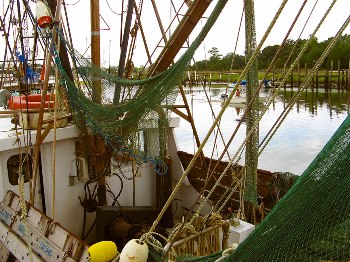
left=0, top=0, right=350, bottom=67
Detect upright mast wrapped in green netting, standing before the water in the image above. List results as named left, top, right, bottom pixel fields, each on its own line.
left=244, top=0, right=259, bottom=205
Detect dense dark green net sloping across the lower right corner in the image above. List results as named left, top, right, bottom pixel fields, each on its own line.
left=227, top=113, right=350, bottom=261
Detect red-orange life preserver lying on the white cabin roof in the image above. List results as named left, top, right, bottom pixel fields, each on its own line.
left=8, top=94, right=55, bottom=109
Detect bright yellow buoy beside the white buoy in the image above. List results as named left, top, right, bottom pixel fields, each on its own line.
left=88, top=241, right=118, bottom=262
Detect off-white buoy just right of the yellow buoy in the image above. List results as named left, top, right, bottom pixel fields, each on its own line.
left=119, top=239, right=148, bottom=262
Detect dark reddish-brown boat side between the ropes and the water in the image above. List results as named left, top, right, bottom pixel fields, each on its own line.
left=177, top=151, right=297, bottom=222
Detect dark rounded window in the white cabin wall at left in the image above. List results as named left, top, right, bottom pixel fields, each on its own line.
left=7, top=154, right=33, bottom=186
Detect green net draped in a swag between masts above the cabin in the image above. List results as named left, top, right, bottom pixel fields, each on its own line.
left=52, top=0, right=227, bottom=171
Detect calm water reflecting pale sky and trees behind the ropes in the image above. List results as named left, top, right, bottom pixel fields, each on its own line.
left=175, top=87, right=350, bottom=175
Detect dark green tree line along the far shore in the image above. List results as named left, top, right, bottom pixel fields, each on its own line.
left=189, top=34, right=350, bottom=71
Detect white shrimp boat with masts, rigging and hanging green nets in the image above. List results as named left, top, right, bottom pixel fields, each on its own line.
left=0, top=0, right=350, bottom=261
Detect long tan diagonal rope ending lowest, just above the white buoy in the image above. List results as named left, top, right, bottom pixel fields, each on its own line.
left=150, top=0, right=288, bottom=232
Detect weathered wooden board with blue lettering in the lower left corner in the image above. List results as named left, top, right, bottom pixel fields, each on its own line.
left=0, top=191, right=89, bottom=262
